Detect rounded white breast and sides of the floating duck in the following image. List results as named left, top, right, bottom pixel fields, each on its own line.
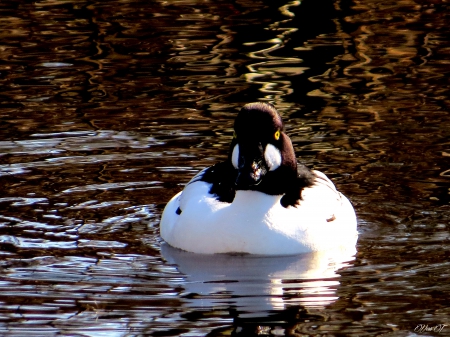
left=160, top=171, right=357, bottom=255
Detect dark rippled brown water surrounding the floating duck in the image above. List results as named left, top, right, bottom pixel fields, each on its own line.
left=0, top=0, right=450, bottom=336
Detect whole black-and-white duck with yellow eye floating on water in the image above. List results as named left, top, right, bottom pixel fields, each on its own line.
left=160, top=102, right=358, bottom=255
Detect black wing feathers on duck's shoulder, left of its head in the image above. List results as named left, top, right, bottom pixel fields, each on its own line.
left=186, top=161, right=237, bottom=203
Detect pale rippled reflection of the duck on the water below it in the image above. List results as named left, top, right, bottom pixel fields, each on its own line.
left=161, top=244, right=356, bottom=318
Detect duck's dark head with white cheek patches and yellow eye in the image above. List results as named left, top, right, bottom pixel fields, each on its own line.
left=229, top=103, right=297, bottom=195
